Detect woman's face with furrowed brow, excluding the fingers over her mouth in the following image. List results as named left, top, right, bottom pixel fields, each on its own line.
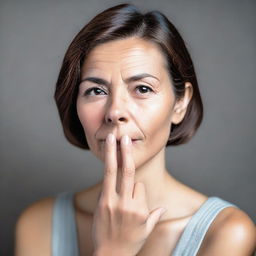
left=77, top=37, right=178, bottom=168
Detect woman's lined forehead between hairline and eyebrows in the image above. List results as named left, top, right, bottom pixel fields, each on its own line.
left=82, top=37, right=166, bottom=76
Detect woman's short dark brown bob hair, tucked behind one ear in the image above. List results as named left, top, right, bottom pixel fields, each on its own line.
left=54, top=4, right=203, bottom=149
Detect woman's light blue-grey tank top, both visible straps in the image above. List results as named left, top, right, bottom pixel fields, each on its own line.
left=52, top=192, right=238, bottom=256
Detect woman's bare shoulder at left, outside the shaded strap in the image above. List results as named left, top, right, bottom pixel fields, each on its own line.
left=15, top=197, right=55, bottom=256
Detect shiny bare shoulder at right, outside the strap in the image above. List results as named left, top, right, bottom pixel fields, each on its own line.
left=198, top=207, right=256, bottom=256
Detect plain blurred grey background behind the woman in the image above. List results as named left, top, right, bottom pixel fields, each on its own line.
left=0, top=0, right=256, bottom=255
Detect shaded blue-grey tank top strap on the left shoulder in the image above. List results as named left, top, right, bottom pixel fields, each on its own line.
left=52, top=192, right=79, bottom=256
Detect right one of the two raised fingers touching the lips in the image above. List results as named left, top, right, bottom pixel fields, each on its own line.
left=120, top=135, right=135, bottom=198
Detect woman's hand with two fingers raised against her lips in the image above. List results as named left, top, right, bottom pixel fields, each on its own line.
left=92, top=134, right=165, bottom=256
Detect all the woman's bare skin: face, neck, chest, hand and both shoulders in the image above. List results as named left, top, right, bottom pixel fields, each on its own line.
left=15, top=38, right=256, bottom=256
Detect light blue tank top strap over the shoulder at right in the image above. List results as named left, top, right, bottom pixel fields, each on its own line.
left=172, top=197, right=238, bottom=256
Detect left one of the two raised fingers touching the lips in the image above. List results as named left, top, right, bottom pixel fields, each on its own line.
left=102, top=133, right=117, bottom=196
